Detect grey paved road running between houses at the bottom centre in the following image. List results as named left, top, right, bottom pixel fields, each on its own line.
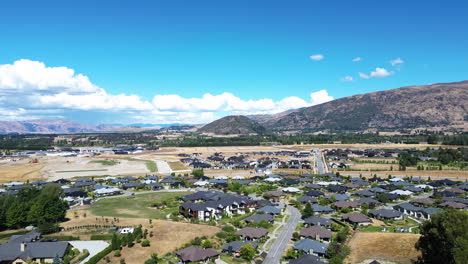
left=263, top=206, right=301, bottom=264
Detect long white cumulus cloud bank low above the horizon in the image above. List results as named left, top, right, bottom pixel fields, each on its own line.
left=0, top=59, right=333, bottom=123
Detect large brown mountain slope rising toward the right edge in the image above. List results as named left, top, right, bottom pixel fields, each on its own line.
left=262, top=81, right=468, bottom=131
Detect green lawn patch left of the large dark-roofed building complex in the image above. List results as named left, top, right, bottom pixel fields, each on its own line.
left=90, top=192, right=191, bottom=219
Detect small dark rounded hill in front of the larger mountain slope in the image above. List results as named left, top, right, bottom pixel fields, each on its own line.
left=198, top=116, right=265, bottom=135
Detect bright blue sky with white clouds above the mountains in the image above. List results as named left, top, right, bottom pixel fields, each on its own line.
left=0, top=0, right=468, bottom=123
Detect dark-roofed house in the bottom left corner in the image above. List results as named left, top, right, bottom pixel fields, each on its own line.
left=0, top=231, right=70, bottom=264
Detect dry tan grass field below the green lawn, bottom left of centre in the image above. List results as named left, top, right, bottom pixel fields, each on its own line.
left=61, top=207, right=221, bottom=264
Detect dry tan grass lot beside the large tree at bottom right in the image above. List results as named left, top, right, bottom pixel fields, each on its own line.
left=345, top=232, right=420, bottom=264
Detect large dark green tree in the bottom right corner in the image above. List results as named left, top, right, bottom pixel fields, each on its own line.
left=416, top=209, right=468, bottom=264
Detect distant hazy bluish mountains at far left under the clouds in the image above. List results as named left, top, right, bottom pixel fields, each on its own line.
left=0, top=119, right=118, bottom=134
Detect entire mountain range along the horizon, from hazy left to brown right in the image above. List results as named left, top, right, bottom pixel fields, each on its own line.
left=0, top=81, right=468, bottom=135
